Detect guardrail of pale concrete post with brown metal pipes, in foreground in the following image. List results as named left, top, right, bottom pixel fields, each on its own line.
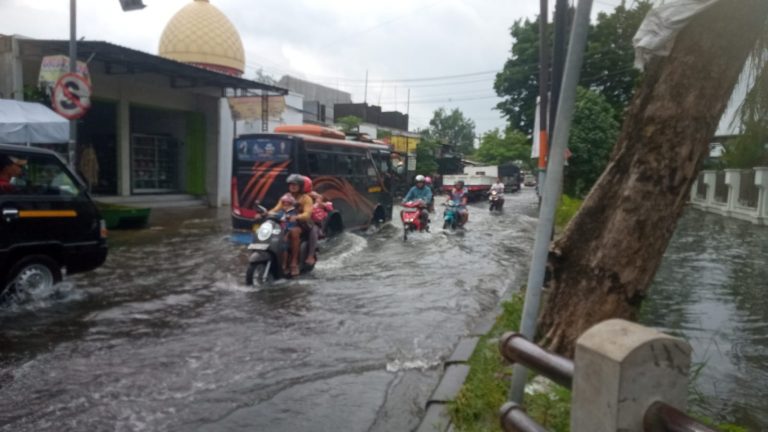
left=499, top=320, right=717, bottom=432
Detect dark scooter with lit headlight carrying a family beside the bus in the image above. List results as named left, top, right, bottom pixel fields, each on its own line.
left=245, top=205, right=317, bottom=286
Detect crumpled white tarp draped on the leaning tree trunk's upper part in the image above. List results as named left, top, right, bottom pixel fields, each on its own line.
left=632, top=0, right=718, bottom=69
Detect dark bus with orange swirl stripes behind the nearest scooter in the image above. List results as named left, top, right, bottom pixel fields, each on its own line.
left=232, top=125, right=395, bottom=232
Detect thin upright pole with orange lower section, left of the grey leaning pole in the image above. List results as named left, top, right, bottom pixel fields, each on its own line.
left=534, top=0, right=549, bottom=199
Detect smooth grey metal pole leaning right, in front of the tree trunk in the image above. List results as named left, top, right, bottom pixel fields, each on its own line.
left=509, top=0, right=592, bottom=403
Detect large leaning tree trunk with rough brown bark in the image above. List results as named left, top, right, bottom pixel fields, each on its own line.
left=539, top=0, right=768, bottom=356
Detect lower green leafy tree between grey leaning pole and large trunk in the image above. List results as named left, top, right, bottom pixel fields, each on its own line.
left=563, top=87, right=619, bottom=197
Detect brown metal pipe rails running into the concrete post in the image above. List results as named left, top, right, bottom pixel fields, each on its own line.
left=499, top=332, right=718, bottom=432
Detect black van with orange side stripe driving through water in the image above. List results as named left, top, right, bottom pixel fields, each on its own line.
left=0, top=144, right=107, bottom=297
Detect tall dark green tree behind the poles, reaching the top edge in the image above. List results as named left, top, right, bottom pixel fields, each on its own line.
left=494, top=0, right=652, bottom=135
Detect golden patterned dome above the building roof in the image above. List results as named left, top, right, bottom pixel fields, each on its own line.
left=159, top=0, right=245, bottom=75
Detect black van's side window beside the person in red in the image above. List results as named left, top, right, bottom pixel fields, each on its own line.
left=0, top=154, right=82, bottom=197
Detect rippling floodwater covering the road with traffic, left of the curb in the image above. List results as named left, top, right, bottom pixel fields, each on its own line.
left=0, top=189, right=536, bottom=432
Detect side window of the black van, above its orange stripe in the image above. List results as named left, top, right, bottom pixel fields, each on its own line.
left=3, top=155, right=82, bottom=197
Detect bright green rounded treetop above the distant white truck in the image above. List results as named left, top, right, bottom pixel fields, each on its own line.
left=473, top=129, right=531, bottom=168
